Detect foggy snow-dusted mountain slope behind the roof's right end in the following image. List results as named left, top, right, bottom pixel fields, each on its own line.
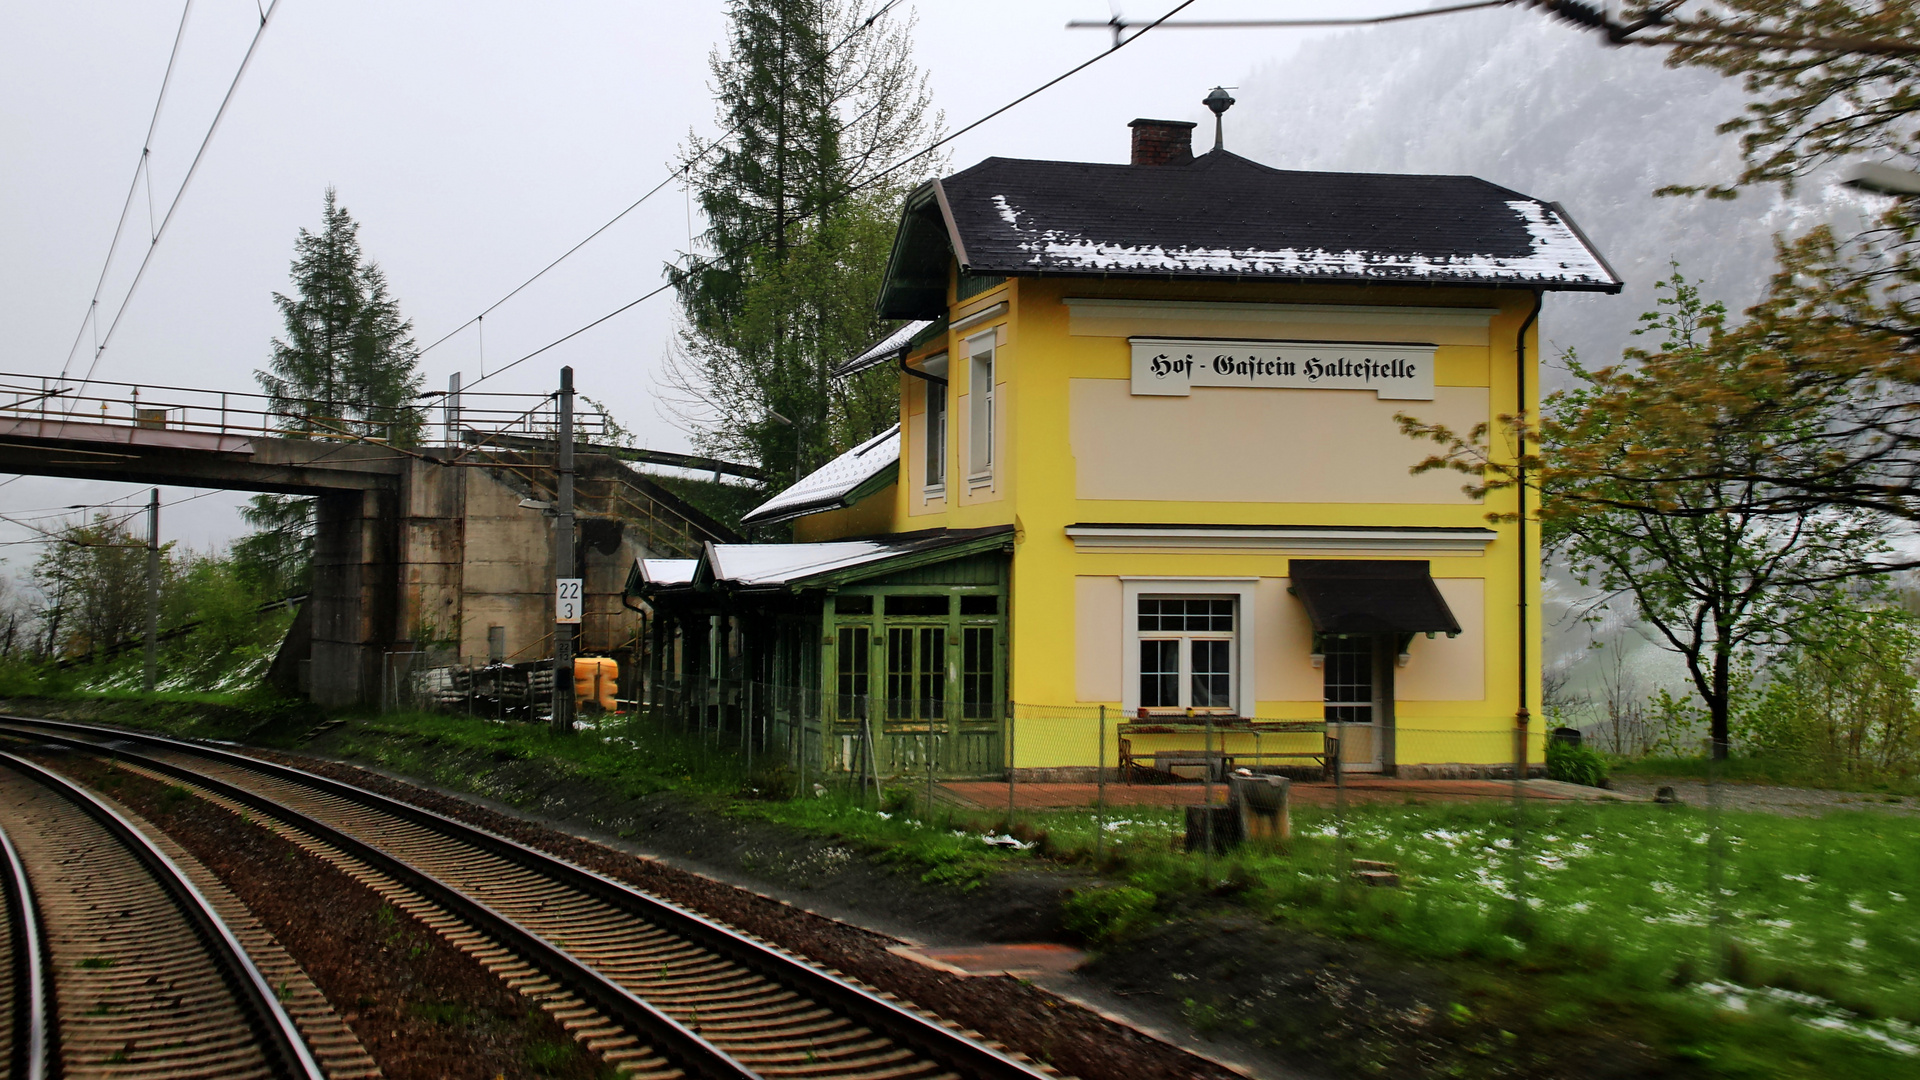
left=1228, top=10, right=1857, bottom=376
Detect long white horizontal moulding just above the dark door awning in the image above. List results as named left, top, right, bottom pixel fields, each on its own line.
left=1066, top=525, right=1500, bottom=557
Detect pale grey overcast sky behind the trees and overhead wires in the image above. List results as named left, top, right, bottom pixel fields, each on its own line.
left=0, top=0, right=1797, bottom=580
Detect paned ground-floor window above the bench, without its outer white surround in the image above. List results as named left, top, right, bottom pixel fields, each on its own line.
left=1137, top=596, right=1238, bottom=713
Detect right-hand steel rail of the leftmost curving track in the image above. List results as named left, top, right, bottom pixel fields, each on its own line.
left=0, top=753, right=324, bottom=1080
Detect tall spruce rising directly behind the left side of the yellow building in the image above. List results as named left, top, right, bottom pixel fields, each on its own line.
left=668, top=0, right=941, bottom=477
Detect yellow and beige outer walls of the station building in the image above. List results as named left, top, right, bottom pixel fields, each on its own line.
left=799, top=279, right=1542, bottom=767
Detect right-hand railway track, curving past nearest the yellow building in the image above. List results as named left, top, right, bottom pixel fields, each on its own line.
left=0, top=717, right=1048, bottom=1080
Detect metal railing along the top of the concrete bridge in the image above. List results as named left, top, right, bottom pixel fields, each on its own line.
left=0, top=371, right=609, bottom=446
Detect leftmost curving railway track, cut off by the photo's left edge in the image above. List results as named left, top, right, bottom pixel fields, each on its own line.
left=0, top=753, right=323, bottom=1080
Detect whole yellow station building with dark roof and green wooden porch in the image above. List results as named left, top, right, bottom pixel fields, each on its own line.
left=630, top=119, right=1620, bottom=780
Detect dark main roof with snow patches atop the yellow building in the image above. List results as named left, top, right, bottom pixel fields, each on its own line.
left=881, top=150, right=1620, bottom=319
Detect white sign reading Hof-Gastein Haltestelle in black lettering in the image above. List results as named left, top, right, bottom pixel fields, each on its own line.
left=1127, top=338, right=1434, bottom=402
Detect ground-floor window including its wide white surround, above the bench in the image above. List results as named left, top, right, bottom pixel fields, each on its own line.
left=1121, top=577, right=1256, bottom=715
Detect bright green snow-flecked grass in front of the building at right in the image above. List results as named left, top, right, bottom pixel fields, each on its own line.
left=1031, top=803, right=1920, bottom=1076
